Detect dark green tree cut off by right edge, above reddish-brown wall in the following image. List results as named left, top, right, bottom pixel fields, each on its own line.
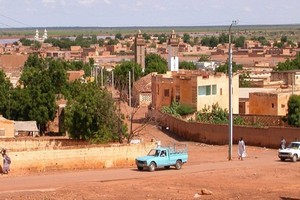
left=287, top=95, right=300, bottom=127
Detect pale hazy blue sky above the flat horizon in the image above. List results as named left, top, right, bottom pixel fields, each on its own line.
left=0, top=0, right=300, bottom=28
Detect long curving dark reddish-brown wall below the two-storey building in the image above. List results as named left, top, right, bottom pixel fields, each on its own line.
left=153, top=111, right=300, bottom=148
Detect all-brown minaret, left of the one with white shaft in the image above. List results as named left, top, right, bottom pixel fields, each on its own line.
left=134, top=30, right=146, bottom=72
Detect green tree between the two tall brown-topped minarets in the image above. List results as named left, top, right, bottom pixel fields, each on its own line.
left=145, top=53, right=168, bottom=74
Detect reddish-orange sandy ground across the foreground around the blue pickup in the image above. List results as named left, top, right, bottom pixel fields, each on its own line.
left=0, top=105, right=300, bottom=200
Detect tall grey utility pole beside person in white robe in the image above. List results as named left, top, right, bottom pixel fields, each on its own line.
left=228, top=21, right=236, bottom=160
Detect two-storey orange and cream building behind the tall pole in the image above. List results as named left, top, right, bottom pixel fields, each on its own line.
left=152, top=70, right=239, bottom=114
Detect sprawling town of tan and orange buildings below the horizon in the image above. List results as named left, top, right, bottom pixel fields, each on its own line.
left=0, top=24, right=300, bottom=138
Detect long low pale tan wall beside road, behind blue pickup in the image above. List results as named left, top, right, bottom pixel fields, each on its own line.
left=3, top=143, right=155, bottom=173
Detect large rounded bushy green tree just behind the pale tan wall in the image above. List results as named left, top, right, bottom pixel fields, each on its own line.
left=65, top=83, right=127, bottom=143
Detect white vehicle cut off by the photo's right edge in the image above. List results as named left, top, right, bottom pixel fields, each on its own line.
left=278, top=142, right=300, bottom=162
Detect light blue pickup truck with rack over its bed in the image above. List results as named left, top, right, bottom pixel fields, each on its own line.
left=135, top=145, right=188, bottom=172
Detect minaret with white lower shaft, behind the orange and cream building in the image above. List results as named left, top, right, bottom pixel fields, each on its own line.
left=168, top=30, right=179, bottom=71
